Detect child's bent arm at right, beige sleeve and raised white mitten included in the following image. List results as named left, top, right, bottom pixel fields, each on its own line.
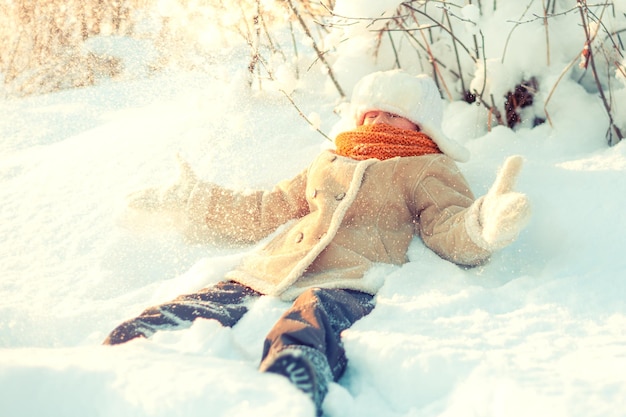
left=414, top=156, right=530, bottom=265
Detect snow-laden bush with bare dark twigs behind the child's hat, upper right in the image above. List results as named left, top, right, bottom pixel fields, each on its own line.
left=290, top=0, right=626, bottom=143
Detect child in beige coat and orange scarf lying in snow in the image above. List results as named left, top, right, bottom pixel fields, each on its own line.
left=104, top=71, right=530, bottom=414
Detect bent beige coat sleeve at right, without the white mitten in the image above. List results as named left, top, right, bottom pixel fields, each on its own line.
left=414, top=157, right=491, bottom=266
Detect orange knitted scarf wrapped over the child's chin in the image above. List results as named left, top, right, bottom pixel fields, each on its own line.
left=335, top=124, right=442, bottom=160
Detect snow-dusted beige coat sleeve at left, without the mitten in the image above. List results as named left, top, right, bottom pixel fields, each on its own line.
left=185, top=170, right=309, bottom=244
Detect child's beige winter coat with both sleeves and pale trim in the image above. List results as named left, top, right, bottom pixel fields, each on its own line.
left=187, top=151, right=490, bottom=300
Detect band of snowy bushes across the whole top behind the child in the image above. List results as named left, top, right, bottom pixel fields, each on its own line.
left=0, top=0, right=626, bottom=144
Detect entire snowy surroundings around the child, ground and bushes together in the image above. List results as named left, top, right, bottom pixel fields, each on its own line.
left=0, top=0, right=626, bottom=417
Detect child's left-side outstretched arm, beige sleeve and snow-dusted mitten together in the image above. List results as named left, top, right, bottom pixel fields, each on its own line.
left=127, top=155, right=309, bottom=243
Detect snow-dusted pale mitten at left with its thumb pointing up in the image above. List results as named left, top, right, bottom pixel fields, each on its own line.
left=126, top=154, right=198, bottom=211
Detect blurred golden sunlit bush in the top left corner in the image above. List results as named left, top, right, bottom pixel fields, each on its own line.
left=0, top=0, right=141, bottom=94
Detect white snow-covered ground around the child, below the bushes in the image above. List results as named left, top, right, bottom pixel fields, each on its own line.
left=0, top=1, right=626, bottom=417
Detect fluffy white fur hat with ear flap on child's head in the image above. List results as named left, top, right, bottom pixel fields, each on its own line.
left=350, top=70, right=469, bottom=162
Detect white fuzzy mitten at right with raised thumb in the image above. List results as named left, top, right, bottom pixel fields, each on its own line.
left=478, top=155, right=530, bottom=250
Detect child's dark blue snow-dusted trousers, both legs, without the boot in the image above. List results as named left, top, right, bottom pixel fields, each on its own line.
left=104, top=281, right=374, bottom=381
